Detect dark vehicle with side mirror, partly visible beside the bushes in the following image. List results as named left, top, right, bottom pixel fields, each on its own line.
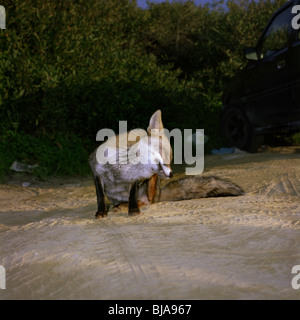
left=221, top=0, right=300, bottom=152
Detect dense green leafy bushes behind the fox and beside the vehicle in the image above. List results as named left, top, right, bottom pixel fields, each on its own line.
left=0, top=0, right=285, bottom=175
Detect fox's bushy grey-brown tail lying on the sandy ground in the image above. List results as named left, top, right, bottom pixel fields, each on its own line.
left=159, top=176, right=245, bottom=201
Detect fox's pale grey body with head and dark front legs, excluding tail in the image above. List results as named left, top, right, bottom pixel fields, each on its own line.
left=89, top=110, right=173, bottom=216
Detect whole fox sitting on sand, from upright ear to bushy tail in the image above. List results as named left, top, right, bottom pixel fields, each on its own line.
left=89, top=110, right=245, bottom=219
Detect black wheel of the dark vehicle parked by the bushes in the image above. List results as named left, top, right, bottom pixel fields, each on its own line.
left=222, top=107, right=263, bottom=152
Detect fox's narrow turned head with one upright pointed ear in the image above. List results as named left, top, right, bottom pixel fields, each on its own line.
left=147, top=110, right=173, bottom=179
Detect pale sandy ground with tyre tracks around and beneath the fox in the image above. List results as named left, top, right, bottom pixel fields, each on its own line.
left=0, top=148, right=300, bottom=299
